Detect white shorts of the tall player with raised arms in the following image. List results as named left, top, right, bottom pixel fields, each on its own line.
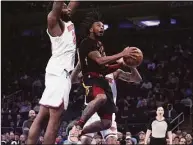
left=39, top=71, right=71, bottom=110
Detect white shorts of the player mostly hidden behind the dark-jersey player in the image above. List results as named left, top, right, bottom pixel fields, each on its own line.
left=84, top=113, right=117, bottom=139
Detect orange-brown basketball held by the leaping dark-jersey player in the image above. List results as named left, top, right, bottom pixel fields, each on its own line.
left=123, top=47, right=143, bottom=66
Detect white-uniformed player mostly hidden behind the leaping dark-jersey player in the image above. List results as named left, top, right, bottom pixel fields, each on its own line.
left=68, top=60, right=142, bottom=144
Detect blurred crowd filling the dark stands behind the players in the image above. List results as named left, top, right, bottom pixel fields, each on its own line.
left=1, top=9, right=193, bottom=144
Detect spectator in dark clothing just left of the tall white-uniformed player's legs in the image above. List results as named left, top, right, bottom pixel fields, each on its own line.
left=22, top=110, right=36, bottom=136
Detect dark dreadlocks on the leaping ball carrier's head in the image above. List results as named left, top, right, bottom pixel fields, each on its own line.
left=80, top=10, right=103, bottom=38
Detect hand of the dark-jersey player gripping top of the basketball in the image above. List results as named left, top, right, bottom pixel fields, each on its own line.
left=122, top=47, right=138, bottom=59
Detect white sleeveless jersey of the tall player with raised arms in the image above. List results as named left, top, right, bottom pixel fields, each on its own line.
left=46, top=21, right=76, bottom=75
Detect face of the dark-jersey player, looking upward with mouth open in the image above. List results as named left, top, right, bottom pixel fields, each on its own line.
left=90, top=22, right=104, bottom=37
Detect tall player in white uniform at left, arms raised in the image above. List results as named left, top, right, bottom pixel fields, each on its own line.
left=27, top=1, right=78, bottom=144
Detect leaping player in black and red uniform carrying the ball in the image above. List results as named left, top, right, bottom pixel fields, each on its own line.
left=69, top=12, right=137, bottom=142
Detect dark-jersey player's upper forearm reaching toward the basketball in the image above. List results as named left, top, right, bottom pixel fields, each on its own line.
left=96, top=53, right=123, bottom=65
